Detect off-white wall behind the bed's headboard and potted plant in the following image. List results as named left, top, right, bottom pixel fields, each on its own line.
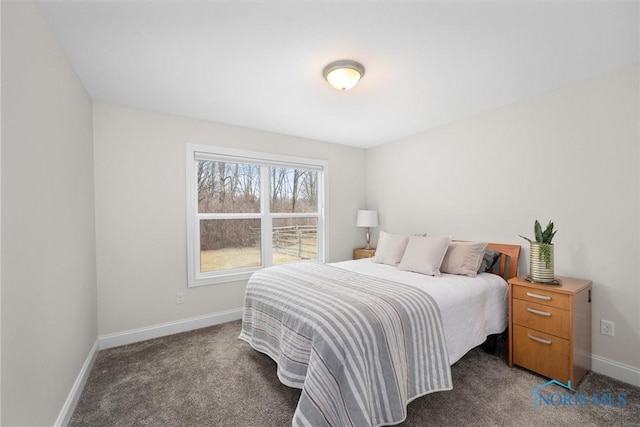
left=367, top=65, right=640, bottom=374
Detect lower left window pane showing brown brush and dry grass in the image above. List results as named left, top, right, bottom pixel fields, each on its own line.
left=200, top=219, right=261, bottom=273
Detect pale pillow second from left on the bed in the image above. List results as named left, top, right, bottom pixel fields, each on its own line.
left=398, top=236, right=451, bottom=276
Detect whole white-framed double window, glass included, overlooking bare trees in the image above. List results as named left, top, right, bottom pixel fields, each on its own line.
left=187, top=145, right=327, bottom=286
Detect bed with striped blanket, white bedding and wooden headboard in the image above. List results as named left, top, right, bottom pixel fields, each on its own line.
left=240, top=239, right=520, bottom=426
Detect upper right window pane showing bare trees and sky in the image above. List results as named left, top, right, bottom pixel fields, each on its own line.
left=269, top=167, right=318, bottom=213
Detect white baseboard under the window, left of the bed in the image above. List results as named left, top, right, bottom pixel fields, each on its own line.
left=98, top=308, right=242, bottom=350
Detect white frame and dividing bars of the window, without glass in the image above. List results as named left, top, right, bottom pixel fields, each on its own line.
left=186, top=144, right=329, bottom=287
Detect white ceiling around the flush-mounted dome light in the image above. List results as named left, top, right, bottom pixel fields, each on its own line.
left=41, top=0, right=640, bottom=147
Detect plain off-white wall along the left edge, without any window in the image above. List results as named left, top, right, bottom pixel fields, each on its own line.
left=1, top=1, right=97, bottom=426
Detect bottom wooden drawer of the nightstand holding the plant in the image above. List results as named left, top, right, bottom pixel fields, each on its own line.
left=513, top=325, right=572, bottom=383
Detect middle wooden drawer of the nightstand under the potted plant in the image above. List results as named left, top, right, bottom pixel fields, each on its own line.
left=512, top=299, right=571, bottom=339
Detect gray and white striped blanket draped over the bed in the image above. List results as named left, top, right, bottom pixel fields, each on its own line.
left=240, top=263, right=452, bottom=426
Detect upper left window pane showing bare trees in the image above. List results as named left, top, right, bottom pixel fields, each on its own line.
left=196, top=160, right=260, bottom=213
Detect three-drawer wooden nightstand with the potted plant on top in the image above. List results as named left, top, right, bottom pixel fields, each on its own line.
left=509, top=276, right=591, bottom=388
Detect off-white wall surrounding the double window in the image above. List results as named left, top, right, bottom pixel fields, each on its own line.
left=94, top=104, right=366, bottom=335
